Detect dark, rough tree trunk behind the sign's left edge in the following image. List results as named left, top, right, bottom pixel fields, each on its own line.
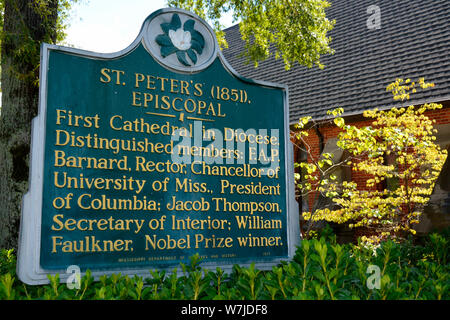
left=0, top=0, right=58, bottom=248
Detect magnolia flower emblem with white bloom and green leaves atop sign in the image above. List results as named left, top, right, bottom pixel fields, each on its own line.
left=155, top=13, right=205, bottom=67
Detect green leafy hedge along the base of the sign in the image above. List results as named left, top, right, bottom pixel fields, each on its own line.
left=0, top=230, right=450, bottom=300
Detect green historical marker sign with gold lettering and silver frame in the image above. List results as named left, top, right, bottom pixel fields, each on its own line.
left=18, top=9, right=299, bottom=284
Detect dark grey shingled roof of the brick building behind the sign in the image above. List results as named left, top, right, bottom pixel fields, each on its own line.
left=223, top=0, right=450, bottom=123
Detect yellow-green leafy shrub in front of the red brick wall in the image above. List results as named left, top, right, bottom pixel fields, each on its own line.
left=300, top=78, right=447, bottom=242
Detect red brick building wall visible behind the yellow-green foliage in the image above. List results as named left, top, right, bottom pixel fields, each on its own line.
left=294, top=103, right=450, bottom=238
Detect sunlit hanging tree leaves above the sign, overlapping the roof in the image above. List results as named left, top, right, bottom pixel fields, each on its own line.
left=168, top=0, right=334, bottom=69
